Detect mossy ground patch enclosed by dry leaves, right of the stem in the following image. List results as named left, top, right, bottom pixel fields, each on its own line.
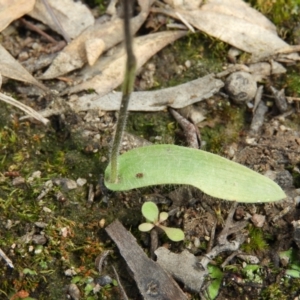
left=151, top=32, right=228, bottom=89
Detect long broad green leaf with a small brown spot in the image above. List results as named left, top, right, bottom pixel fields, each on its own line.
left=105, top=145, right=286, bottom=203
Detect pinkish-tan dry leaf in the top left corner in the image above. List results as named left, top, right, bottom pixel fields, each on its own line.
left=0, top=0, right=35, bottom=31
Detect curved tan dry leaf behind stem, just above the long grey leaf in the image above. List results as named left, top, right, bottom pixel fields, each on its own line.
left=66, top=31, right=187, bottom=96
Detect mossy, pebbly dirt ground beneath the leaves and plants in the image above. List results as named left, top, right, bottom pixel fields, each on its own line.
left=0, top=0, right=300, bottom=300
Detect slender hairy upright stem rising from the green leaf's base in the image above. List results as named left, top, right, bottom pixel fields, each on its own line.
left=110, top=0, right=136, bottom=183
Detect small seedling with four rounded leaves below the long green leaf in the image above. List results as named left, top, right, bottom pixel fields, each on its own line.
left=139, top=202, right=184, bottom=242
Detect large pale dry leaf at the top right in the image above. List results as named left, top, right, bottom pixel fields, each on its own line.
left=157, top=0, right=296, bottom=56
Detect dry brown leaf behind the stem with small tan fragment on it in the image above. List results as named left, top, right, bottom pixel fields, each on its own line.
left=40, top=0, right=153, bottom=79
